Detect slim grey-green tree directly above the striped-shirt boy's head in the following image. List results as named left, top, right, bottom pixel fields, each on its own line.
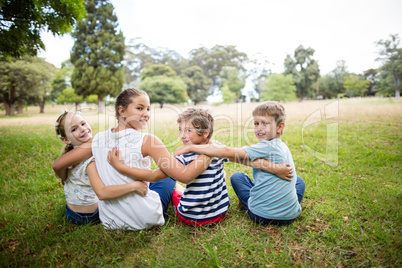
left=182, top=66, right=211, bottom=105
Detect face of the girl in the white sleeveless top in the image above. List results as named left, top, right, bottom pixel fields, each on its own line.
left=121, top=95, right=151, bottom=129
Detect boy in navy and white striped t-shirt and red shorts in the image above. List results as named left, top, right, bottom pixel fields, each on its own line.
left=108, top=105, right=288, bottom=226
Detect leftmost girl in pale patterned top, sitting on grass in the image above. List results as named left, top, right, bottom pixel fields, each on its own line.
left=52, top=111, right=148, bottom=224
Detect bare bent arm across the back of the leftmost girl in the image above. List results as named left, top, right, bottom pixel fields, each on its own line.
left=52, top=139, right=92, bottom=181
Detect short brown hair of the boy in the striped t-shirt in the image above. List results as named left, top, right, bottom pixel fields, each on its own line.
left=177, top=107, right=214, bottom=139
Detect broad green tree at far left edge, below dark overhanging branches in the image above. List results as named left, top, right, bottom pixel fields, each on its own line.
left=0, top=57, right=55, bottom=115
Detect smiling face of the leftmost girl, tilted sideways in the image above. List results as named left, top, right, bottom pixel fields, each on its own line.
left=64, top=113, right=92, bottom=146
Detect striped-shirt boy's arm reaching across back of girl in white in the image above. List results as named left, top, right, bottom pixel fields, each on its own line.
left=107, top=148, right=169, bottom=182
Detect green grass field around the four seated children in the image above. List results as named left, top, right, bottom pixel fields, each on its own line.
left=0, top=99, right=402, bottom=267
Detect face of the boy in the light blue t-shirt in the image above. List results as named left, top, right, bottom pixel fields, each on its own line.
left=254, top=115, right=283, bottom=141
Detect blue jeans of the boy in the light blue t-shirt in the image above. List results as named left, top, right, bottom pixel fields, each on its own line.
left=230, top=172, right=306, bottom=225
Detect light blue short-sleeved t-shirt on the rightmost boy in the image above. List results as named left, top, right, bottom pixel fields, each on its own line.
left=243, top=139, right=301, bottom=220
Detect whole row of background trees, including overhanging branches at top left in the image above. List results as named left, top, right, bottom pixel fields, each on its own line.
left=0, top=0, right=402, bottom=115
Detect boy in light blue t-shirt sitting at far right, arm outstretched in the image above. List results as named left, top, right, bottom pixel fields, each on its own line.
left=176, top=101, right=305, bottom=225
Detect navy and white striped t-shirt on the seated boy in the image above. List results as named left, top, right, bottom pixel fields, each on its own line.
left=176, top=153, right=229, bottom=221
